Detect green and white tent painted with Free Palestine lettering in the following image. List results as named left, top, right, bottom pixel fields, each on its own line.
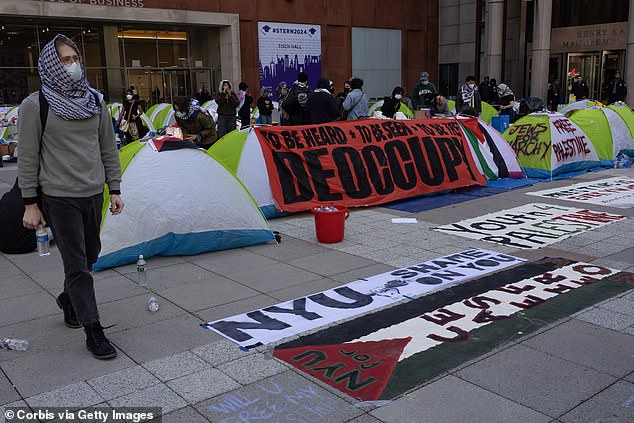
left=503, top=112, right=601, bottom=179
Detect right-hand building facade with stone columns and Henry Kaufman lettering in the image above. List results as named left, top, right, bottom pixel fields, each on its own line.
left=438, top=0, right=634, bottom=100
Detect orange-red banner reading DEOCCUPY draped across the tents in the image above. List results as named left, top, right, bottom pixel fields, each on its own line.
left=255, top=119, right=486, bottom=212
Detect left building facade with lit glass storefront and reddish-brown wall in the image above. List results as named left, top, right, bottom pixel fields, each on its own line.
left=0, top=0, right=438, bottom=104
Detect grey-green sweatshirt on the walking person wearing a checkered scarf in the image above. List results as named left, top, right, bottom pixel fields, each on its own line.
left=18, top=92, right=121, bottom=204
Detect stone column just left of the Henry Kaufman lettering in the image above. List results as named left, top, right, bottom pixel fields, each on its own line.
left=529, top=0, right=553, bottom=103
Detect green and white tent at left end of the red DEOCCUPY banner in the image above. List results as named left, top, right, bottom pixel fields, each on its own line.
left=207, top=128, right=283, bottom=219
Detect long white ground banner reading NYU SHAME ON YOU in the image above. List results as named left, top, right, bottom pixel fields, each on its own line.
left=202, top=248, right=526, bottom=347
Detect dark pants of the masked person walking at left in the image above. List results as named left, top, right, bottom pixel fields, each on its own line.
left=42, top=194, right=103, bottom=325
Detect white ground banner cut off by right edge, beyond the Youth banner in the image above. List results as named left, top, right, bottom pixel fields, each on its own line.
left=527, top=177, right=634, bottom=209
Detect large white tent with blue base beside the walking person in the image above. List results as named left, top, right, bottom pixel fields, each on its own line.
left=94, top=138, right=274, bottom=270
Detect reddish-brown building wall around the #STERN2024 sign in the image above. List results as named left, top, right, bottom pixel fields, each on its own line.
left=144, top=0, right=439, bottom=95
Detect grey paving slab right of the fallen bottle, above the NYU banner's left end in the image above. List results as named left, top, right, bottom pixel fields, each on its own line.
left=159, top=274, right=259, bottom=311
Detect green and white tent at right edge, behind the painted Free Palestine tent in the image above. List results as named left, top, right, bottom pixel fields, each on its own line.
left=568, top=106, right=634, bottom=167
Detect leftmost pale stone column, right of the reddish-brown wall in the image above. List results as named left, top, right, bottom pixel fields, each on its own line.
left=485, top=0, right=505, bottom=81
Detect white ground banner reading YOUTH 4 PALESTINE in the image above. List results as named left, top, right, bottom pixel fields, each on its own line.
left=434, top=204, right=625, bottom=249
